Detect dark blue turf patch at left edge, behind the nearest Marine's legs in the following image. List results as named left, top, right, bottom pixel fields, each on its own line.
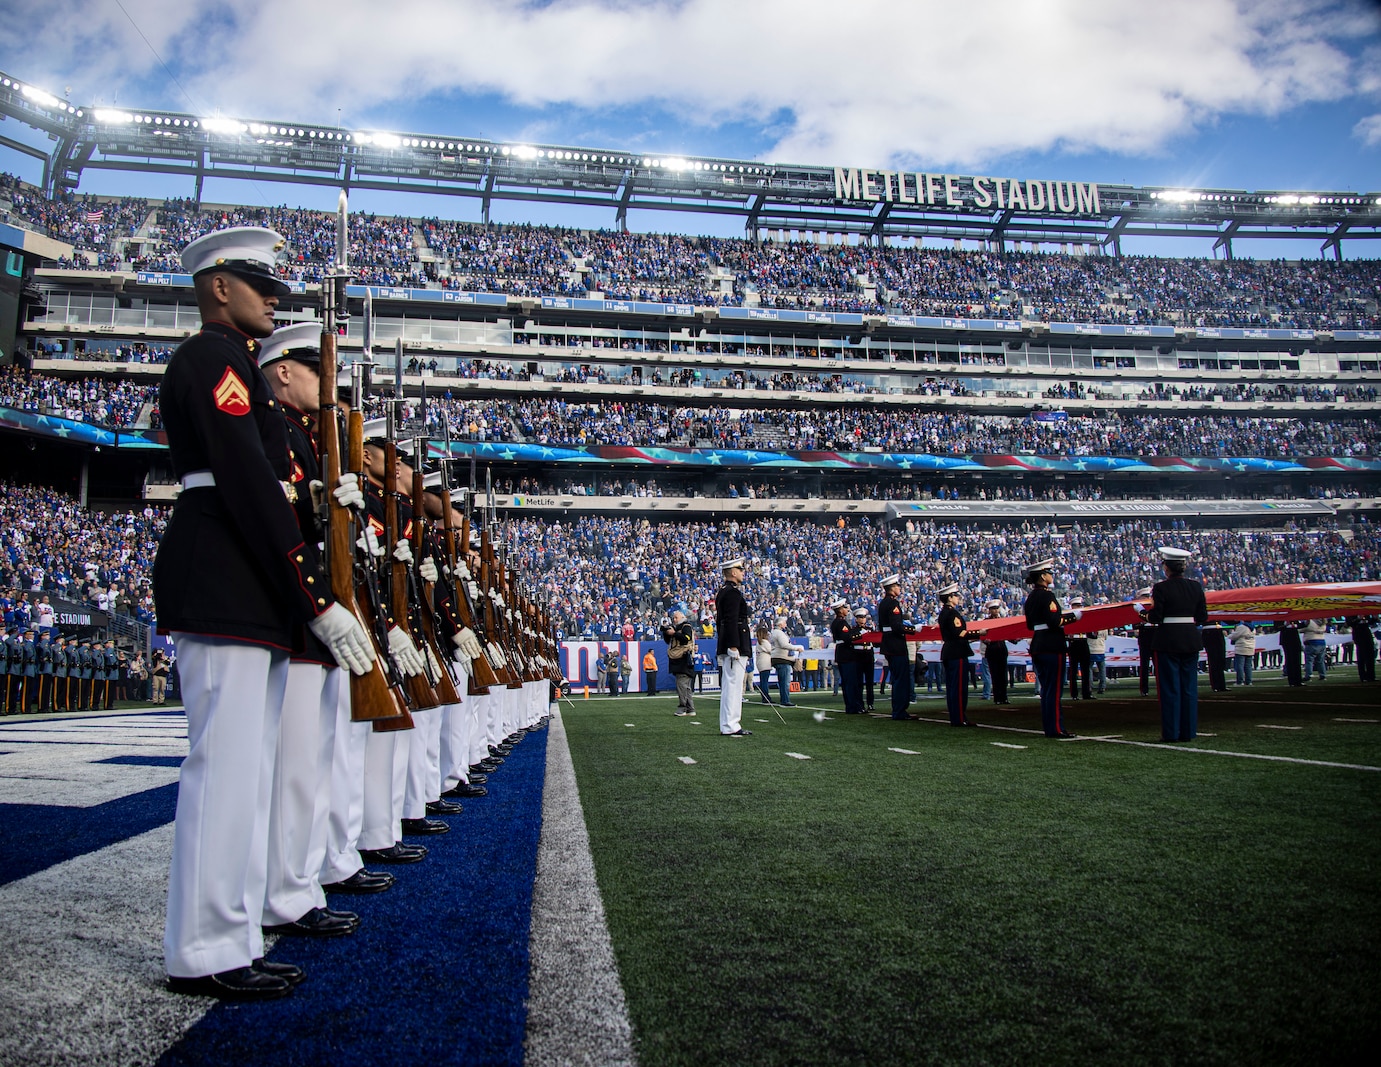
left=0, top=781, right=177, bottom=885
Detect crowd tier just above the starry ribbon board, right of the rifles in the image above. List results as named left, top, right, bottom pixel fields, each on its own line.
left=369, top=391, right=1381, bottom=457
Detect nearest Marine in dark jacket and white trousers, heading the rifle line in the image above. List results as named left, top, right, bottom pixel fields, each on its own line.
left=153, top=226, right=374, bottom=1001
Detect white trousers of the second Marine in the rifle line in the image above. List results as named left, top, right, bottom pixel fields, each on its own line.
left=264, top=663, right=340, bottom=925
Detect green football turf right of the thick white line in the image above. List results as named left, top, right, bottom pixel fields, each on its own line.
left=563, top=671, right=1381, bottom=1067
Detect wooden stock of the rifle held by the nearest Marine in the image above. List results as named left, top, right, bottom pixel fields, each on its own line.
left=316, top=330, right=400, bottom=722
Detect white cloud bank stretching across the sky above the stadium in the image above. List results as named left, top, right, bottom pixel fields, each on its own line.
left=0, top=0, right=1375, bottom=167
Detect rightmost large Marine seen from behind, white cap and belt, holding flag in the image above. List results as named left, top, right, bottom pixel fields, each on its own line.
left=1146, top=547, right=1208, bottom=741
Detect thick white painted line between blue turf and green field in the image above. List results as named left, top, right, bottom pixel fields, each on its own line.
left=523, top=711, right=637, bottom=1067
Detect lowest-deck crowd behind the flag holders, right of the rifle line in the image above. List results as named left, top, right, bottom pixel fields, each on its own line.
left=512, top=516, right=1381, bottom=635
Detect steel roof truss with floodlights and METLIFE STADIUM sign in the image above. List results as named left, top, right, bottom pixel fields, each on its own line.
left=0, top=72, right=1381, bottom=258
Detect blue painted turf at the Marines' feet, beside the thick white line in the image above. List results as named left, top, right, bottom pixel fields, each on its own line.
left=159, top=730, right=547, bottom=1067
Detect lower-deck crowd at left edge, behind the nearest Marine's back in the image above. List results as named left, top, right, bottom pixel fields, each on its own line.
left=0, top=482, right=167, bottom=623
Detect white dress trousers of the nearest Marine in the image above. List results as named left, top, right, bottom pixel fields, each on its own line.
left=163, top=634, right=287, bottom=979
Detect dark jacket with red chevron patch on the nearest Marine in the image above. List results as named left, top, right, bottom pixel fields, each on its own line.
left=153, top=322, right=333, bottom=650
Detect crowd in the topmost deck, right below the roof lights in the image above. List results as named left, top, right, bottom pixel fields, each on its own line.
left=0, top=177, right=1381, bottom=329
